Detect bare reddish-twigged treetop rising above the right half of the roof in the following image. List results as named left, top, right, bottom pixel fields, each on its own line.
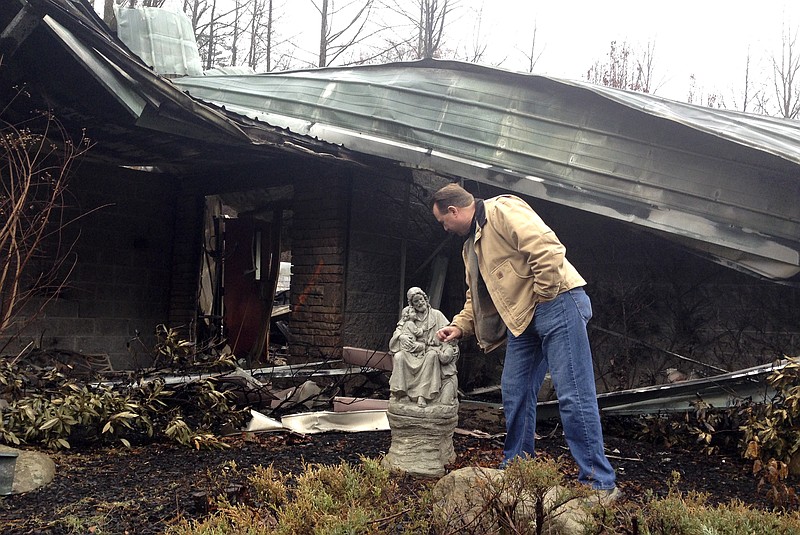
left=586, top=41, right=657, bottom=93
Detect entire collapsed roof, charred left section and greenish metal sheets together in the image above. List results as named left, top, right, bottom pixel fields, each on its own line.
left=6, top=0, right=800, bottom=284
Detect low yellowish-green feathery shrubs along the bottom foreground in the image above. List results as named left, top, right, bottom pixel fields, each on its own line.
left=166, top=452, right=800, bottom=535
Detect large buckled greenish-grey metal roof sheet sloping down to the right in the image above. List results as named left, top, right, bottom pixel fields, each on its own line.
left=175, top=60, right=800, bottom=280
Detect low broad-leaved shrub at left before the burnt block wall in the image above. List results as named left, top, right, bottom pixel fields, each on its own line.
left=0, top=327, right=247, bottom=449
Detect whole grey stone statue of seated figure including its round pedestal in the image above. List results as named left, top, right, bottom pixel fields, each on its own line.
left=384, top=287, right=459, bottom=477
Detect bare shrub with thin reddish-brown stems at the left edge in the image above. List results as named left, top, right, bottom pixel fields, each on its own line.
left=0, top=98, right=89, bottom=350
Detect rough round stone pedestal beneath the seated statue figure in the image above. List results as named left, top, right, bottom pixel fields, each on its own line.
left=383, top=399, right=458, bottom=477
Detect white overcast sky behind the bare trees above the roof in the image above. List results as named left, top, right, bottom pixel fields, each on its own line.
left=108, top=0, right=800, bottom=101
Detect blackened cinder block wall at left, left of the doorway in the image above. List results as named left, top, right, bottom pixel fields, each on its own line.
left=6, top=164, right=175, bottom=369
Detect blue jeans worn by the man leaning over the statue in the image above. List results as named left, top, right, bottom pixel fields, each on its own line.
left=500, top=288, right=616, bottom=489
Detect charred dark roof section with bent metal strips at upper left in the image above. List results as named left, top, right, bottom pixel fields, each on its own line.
left=0, top=0, right=360, bottom=173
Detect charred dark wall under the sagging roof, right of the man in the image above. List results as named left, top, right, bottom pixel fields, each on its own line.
left=531, top=196, right=800, bottom=391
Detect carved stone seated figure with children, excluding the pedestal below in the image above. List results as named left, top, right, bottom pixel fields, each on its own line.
left=389, top=287, right=458, bottom=407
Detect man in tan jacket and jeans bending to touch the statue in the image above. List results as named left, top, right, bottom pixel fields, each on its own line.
left=432, top=184, right=617, bottom=499
